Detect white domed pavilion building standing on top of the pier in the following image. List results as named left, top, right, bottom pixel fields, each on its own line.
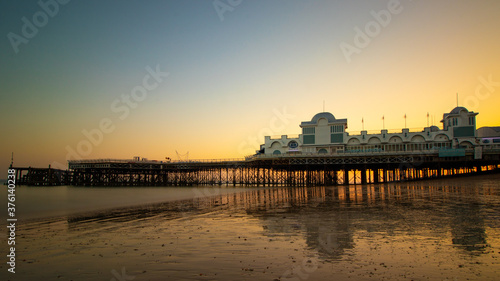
left=258, top=107, right=480, bottom=156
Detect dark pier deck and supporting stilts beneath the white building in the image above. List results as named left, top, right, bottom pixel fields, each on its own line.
left=14, top=148, right=500, bottom=186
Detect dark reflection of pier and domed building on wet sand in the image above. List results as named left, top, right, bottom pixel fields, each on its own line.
left=68, top=178, right=498, bottom=260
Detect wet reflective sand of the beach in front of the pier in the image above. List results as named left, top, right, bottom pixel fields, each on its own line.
left=0, top=175, right=500, bottom=281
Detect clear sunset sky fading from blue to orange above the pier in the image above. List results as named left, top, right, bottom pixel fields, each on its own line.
left=0, top=0, right=500, bottom=178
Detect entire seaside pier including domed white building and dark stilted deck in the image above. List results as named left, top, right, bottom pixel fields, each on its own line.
left=8, top=106, right=500, bottom=186
